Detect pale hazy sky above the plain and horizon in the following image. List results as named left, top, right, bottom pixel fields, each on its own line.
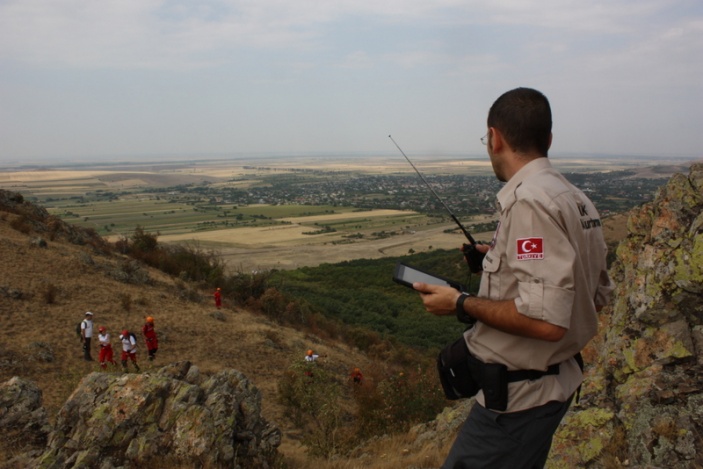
left=0, top=0, right=703, bottom=163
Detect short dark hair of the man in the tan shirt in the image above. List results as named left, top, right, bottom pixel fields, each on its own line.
left=488, top=88, right=552, bottom=156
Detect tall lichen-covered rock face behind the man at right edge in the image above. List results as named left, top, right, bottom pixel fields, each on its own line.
left=550, top=164, right=703, bottom=468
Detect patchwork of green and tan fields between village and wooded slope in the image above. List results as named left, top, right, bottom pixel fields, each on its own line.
left=49, top=198, right=490, bottom=271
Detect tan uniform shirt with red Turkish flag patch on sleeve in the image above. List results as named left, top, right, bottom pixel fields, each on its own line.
left=465, top=158, right=612, bottom=412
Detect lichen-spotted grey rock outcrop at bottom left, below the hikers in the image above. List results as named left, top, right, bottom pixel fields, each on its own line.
left=1, top=362, right=281, bottom=469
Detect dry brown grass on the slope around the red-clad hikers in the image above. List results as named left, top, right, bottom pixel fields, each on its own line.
left=0, top=213, right=456, bottom=469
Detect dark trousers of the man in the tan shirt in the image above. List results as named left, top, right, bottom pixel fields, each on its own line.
left=442, top=396, right=573, bottom=469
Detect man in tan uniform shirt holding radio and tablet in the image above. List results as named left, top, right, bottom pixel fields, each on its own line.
left=413, top=88, right=612, bottom=469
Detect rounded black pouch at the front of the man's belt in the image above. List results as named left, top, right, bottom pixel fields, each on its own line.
left=437, top=336, right=480, bottom=400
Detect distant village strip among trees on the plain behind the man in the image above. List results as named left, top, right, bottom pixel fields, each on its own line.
left=146, top=171, right=667, bottom=216
